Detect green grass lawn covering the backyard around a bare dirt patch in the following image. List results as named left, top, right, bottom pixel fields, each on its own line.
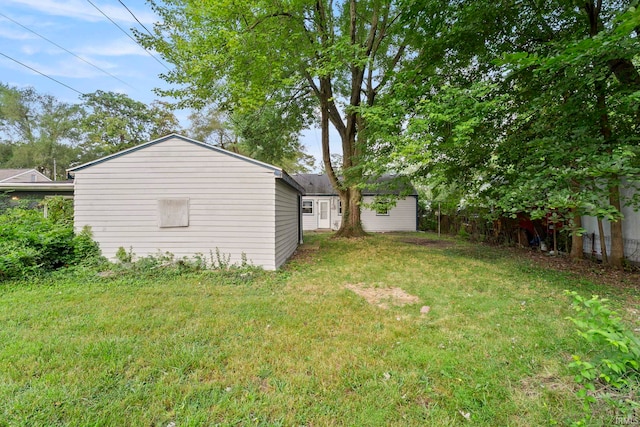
left=0, top=233, right=640, bottom=427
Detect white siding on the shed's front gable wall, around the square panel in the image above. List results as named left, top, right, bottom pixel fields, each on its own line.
left=75, top=138, right=297, bottom=269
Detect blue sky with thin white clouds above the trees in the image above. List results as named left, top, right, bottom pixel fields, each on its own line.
left=0, top=0, right=320, bottom=169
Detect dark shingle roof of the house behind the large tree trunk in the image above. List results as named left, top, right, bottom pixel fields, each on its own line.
left=293, top=173, right=418, bottom=196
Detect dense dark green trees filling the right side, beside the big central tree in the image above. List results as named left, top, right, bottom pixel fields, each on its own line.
left=369, top=0, right=640, bottom=265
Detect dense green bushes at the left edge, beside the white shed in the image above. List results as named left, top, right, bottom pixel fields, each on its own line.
left=0, top=208, right=100, bottom=280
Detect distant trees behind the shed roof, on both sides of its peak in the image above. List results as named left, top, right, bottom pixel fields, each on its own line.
left=0, top=84, right=313, bottom=180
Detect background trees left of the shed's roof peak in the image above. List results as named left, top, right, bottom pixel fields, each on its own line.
left=0, top=83, right=185, bottom=174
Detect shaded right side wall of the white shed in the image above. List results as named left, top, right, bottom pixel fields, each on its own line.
left=275, top=181, right=299, bottom=268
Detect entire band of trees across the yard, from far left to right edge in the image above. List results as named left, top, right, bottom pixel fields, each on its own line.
left=0, top=0, right=640, bottom=266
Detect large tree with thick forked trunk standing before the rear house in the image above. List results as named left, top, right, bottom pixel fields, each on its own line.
left=138, top=0, right=415, bottom=236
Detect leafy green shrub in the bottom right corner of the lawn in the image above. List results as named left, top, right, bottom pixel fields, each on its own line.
left=566, top=291, right=640, bottom=422
